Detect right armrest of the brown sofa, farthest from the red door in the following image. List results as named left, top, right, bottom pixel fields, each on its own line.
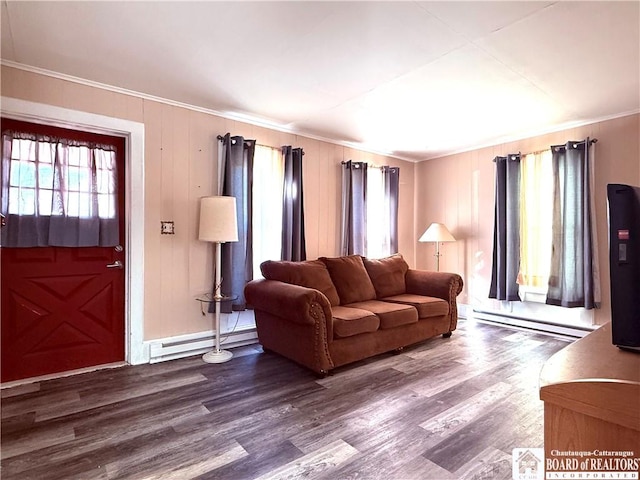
left=405, top=269, right=464, bottom=332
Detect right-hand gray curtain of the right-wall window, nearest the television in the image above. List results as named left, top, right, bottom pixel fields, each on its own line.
left=547, top=138, right=600, bottom=309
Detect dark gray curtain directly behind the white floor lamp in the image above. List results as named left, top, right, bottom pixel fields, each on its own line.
left=212, top=133, right=255, bottom=313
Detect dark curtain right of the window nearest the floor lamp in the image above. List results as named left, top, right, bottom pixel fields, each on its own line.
left=281, top=145, right=307, bottom=261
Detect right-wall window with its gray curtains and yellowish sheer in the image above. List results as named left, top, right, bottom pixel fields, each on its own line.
left=489, top=138, right=600, bottom=310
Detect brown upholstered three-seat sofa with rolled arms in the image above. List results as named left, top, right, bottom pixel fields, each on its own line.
left=245, top=254, right=463, bottom=375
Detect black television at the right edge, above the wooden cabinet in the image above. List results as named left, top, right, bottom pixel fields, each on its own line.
left=607, top=184, right=640, bottom=352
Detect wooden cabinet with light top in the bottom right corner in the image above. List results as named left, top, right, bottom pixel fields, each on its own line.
left=540, top=323, right=640, bottom=471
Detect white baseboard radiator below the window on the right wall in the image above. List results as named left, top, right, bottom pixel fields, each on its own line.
left=460, top=305, right=593, bottom=340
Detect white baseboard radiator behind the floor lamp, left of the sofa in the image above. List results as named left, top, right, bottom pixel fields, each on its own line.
left=148, top=328, right=258, bottom=363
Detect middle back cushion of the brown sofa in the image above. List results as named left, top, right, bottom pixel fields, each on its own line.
left=320, top=255, right=376, bottom=305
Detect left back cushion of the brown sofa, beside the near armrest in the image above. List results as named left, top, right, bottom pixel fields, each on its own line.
left=260, top=260, right=340, bottom=306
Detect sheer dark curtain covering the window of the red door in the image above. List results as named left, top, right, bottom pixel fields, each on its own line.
left=1, top=130, right=120, bottom=247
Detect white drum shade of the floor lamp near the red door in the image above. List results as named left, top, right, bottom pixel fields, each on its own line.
left=198, top=197, right=238, bottom=243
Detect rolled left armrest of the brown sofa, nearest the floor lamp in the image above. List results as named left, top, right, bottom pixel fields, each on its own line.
left=244, top=279, right=333, bottom=339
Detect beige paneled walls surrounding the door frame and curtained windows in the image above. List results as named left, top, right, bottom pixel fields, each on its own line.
left=1, top=62, right=640, bottom=334
